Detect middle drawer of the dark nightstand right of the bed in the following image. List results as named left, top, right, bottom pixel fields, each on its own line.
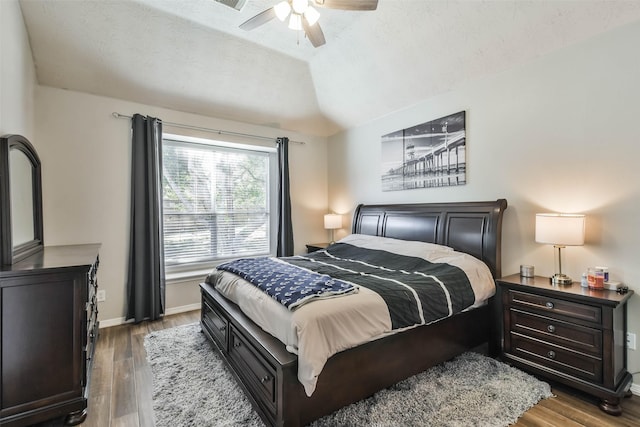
left=510, top=308, right=602, bottom=357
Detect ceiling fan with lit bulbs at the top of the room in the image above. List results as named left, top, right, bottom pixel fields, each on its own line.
left=240, top=0, right=378, bottom=47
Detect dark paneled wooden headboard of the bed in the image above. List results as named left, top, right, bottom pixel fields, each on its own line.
left=352, top=199, right=507, bottom=278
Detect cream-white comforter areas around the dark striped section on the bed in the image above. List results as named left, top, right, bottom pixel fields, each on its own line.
left=207, top=234, right=495, bottom=396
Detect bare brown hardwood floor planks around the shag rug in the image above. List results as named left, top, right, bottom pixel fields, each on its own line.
left=38, top=311, right=640, bottom=427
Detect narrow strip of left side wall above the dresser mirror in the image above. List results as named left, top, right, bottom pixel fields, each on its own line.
left=0, top=0, right=38, bottom=137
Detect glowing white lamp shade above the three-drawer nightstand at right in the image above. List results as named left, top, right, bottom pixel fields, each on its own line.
left=536, top=213, right=585, bottom=246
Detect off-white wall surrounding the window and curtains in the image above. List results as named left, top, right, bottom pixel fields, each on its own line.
left=34, top=86, right=328, bottom=326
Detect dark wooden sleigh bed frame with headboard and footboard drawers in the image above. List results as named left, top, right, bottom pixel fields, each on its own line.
left=200, top=199, right=507, bottom=426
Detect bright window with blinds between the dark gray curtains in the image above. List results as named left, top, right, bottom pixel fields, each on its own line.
left=162, top=135, right=277, bottom=270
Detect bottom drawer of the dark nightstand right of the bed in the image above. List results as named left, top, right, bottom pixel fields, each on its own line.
left=510, top=332, right=602, bottom=383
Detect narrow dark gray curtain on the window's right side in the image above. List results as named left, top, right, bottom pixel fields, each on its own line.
left=276, top=137, right=293, bottom=256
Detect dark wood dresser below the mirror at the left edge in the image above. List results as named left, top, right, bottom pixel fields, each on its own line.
left=0, top=244, right=100, bottom=426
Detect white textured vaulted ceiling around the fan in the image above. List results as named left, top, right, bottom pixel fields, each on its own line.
left=20, top=0, right=640, bottom=136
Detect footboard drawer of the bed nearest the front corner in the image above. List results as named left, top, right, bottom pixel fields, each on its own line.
left=229, top=325, right=276, bottom=417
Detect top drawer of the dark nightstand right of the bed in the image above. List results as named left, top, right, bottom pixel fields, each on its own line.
left=508, top=289, right=602, bottom=324
